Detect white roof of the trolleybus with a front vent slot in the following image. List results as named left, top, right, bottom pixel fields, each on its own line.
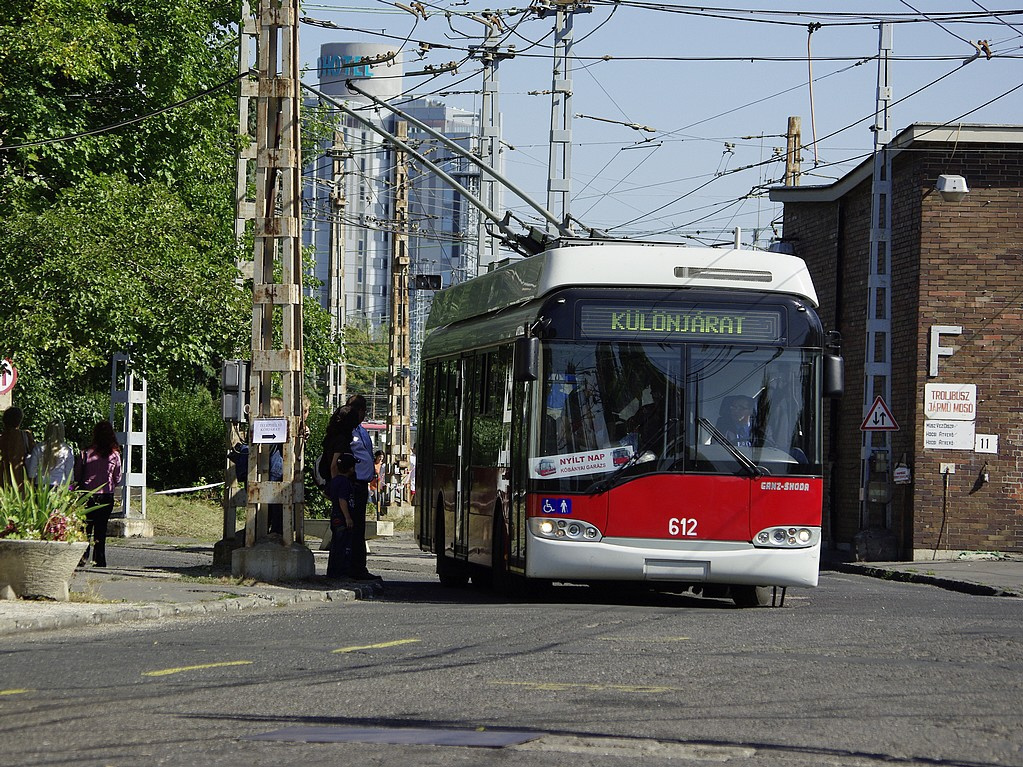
left=427, top=240, right=817, bottom=329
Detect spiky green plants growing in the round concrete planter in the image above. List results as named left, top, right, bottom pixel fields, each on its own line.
left=0, top=478, right=92, bottom=541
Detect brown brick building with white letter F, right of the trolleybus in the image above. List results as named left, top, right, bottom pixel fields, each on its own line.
left=770, top=123, right=1023, bottom=559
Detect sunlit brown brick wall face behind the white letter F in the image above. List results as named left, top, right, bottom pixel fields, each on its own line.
left=913, top=144, right=1023, bottom=551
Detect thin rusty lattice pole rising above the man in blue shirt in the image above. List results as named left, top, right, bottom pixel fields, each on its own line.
left=326, top=131, right=352, bottom=412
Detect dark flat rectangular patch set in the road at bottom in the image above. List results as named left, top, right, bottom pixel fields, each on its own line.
left=241, top=727, right=542, bottom=749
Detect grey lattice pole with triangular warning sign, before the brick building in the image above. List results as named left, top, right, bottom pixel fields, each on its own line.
left=855, top=22, right=897, bottom=560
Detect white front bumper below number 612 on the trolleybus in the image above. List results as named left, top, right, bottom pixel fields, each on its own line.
left=526, top=532, right=820, bottom=587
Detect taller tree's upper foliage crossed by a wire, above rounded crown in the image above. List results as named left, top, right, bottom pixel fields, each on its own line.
left=0, top=0, right=237, bottom=213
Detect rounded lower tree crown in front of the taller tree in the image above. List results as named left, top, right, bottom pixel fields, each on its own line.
left=0, top=176, right=248, bottom=396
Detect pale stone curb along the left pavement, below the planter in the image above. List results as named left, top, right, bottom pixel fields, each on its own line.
left=0, top=585, right=380, bottom=637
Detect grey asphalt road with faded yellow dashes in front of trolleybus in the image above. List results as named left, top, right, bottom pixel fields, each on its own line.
left=0, top=545, right=1023, bottom=767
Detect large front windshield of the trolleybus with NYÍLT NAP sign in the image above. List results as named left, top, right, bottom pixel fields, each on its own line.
left=530, top=341, right=820, bottom=492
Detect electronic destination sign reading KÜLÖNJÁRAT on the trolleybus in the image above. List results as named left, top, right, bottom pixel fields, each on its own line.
left=579, top=305, right=784, bottom=343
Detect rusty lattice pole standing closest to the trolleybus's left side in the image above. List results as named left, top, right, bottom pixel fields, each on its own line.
left=384, top=121, right=411, bottom=517
